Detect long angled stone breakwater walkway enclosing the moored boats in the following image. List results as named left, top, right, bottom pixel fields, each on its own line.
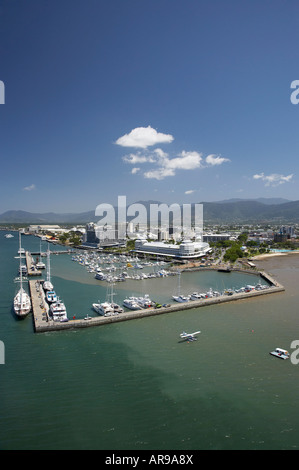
left=29, top=271, right=285, bottom=333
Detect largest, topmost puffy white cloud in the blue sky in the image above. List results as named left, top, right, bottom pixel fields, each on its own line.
left=116, top=126, right=174, bottom=149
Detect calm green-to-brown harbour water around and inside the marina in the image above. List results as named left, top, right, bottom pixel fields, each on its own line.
left=0, top=232, right=299, bottom=450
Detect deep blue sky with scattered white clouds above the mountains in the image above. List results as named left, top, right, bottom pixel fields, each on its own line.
left=0, top=0, right=299, bottom=213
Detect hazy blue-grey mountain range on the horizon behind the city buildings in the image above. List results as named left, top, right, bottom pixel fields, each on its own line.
left=0, top=198, right=299, bottom=225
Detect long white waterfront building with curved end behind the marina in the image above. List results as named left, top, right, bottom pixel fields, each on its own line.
left=134, top=238, right=211, bottom=259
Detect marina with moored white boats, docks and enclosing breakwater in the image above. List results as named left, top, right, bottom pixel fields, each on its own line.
left=9, top=235, right=284, bottom=333
